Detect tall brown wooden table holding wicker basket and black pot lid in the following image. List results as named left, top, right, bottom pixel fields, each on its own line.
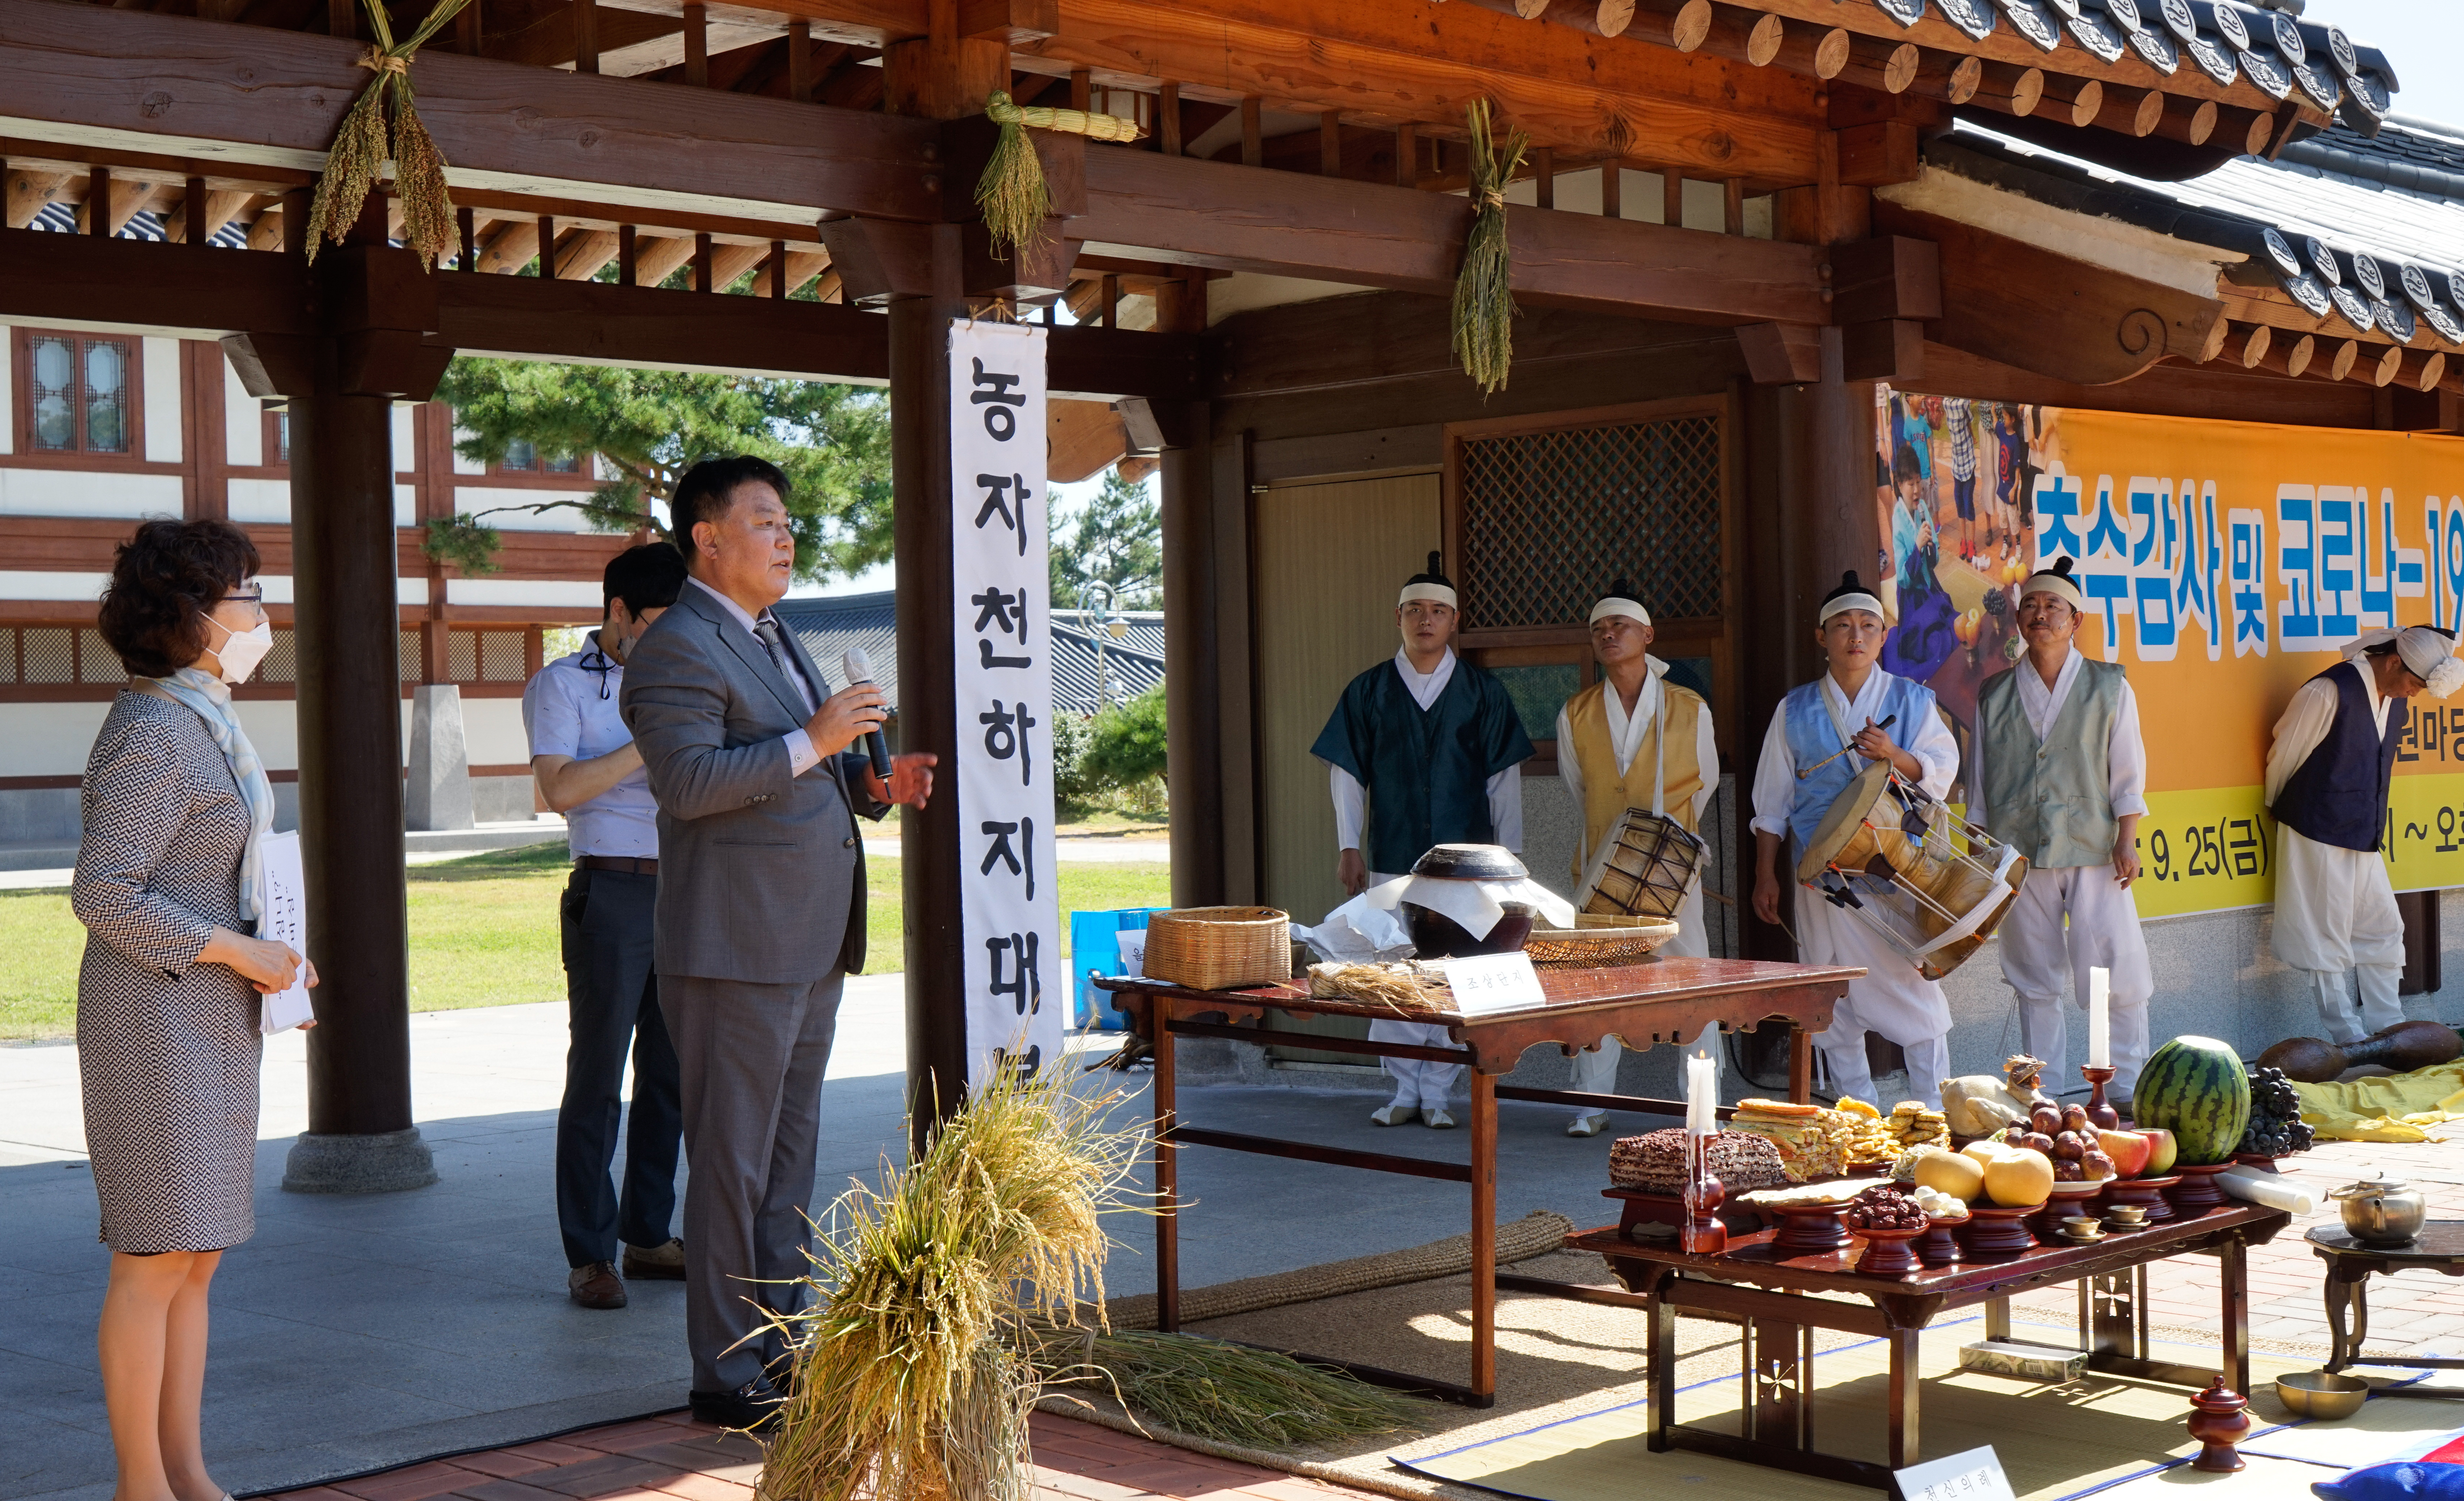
left=1094, top=959, right=1865, bottom=1407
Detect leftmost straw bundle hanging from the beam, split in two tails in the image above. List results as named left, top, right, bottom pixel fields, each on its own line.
left=308, top=0, right=468, bottom=271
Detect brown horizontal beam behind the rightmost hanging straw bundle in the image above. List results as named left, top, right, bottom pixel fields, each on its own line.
left=1069, top=145, right=1828, bottom=323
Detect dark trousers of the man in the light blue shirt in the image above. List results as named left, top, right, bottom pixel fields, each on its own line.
left=557, top=867, right=685, bottom=1267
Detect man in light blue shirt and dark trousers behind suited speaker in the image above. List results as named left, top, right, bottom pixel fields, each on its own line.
left=522, top=542, right=685, bottom=1309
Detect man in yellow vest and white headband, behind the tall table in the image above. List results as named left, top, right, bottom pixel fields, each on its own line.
left=1557, top=579, right=1720, bottom=1136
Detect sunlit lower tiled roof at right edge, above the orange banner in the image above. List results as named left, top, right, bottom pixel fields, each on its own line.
left=1927, top=121, right=2464, bottom=350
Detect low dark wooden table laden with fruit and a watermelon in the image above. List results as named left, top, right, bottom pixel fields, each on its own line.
left=1567, top=1200, right=2292, bottom=1491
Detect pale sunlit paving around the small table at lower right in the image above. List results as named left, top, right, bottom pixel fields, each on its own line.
left=2021, top=1131, right=2464, bottom=1356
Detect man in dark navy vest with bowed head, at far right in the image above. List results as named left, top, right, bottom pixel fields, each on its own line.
left=2267, top=626, right=2464, bottom=1042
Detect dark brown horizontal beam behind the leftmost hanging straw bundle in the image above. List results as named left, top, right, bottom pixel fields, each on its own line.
left=0, top=0, right=941, bottom=222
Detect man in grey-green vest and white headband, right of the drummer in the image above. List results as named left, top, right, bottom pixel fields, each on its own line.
left=1969, top=557, right=2156, bottom=1104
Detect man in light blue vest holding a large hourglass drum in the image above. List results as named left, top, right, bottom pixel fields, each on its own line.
left=1754, top=572, right=1959, bottom=1109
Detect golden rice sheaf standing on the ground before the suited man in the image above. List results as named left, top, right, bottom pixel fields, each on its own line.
left=761, top=1060, right=1146, bottom=1501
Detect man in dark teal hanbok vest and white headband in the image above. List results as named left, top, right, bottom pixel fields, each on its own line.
left=1308, top=552, right=1533, bottom=1129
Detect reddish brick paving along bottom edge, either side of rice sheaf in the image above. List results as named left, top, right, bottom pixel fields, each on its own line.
left=271, top=1412, right=1367, bottom=1501
